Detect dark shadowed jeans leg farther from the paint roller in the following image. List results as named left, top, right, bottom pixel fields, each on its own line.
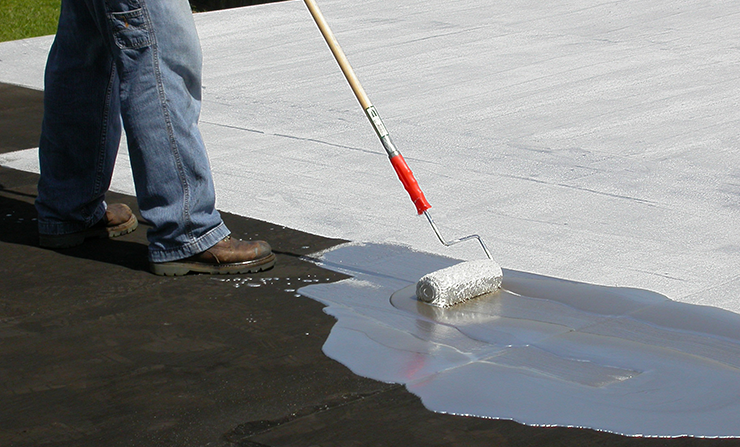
left=36, top=0, right=125, bottom=246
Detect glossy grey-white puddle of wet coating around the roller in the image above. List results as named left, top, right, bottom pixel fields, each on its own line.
left=299, top=244, right=740, bottom=437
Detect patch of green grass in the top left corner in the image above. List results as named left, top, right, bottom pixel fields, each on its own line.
left=0, top=0, right=62, bottom=42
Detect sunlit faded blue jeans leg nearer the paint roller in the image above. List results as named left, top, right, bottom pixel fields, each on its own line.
left=40, top=0, right=229, bottom=262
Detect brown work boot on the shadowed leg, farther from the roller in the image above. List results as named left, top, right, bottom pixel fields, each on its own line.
left=39, top=203, right=139, bottom=249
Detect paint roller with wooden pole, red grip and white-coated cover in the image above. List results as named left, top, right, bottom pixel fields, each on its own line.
left=304, top=0, right=503, bottom=307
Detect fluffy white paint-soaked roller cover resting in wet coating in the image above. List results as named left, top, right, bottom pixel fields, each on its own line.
left=416, top=259, right=504, bottom=307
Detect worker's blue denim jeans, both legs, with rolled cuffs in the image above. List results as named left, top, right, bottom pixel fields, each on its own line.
left=36, top=0, right=229, bottom=262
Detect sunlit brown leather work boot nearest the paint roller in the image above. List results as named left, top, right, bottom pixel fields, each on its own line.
left=151, top=236, right=275, bottom=276
